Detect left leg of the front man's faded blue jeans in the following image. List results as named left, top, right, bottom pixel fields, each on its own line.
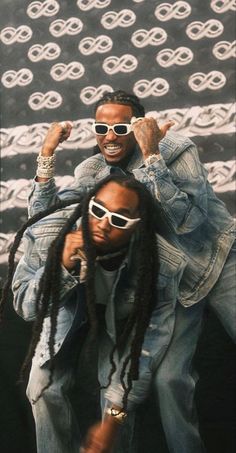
left=26, top=329, right=86, bottom=453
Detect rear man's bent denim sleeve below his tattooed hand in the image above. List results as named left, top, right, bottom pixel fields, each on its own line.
left=133, top=145, right=208, bottom=235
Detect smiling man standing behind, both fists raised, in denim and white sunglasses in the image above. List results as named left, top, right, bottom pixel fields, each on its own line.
left=27, top=90, right=236, bottom=453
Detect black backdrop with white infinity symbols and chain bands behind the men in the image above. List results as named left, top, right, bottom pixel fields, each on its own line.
left=0, top=0, right=236, bottom=453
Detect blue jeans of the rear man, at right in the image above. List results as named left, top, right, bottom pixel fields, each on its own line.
left=154, top=244, right=236, bottom=453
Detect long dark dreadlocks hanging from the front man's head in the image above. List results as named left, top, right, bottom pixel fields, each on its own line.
left=0, top=174, right=158, bottom=408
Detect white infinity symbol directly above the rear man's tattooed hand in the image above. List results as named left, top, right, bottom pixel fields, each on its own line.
left=133, top=77, right=169, bottom=98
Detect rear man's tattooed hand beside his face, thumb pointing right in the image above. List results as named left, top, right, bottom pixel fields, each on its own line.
left=131, top=117, right=174, bottom=159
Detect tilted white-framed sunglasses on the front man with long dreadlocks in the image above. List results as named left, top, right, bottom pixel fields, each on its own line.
left=89, top=197, right=141, bottom=230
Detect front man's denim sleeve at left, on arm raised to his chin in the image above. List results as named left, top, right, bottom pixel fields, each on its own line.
left=12, top=232, right=78, bottom=321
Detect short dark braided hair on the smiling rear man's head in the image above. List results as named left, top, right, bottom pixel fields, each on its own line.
left=94, top=90, right=145, bottom=117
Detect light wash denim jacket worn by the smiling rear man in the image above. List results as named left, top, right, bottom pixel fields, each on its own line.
left=29, top=131, right=235, bottom=307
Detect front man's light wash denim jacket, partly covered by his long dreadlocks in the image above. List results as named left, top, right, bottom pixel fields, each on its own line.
left=12, top=208, right=186, bottom=409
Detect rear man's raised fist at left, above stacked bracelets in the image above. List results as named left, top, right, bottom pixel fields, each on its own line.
left=41, top=121, right=72, bottom=156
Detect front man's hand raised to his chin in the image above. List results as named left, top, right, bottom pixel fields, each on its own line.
left=62, top=229, right=85, bottom=270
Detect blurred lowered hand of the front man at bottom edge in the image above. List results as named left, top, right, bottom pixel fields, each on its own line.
left=80, top=416, right=120, bottom=453
